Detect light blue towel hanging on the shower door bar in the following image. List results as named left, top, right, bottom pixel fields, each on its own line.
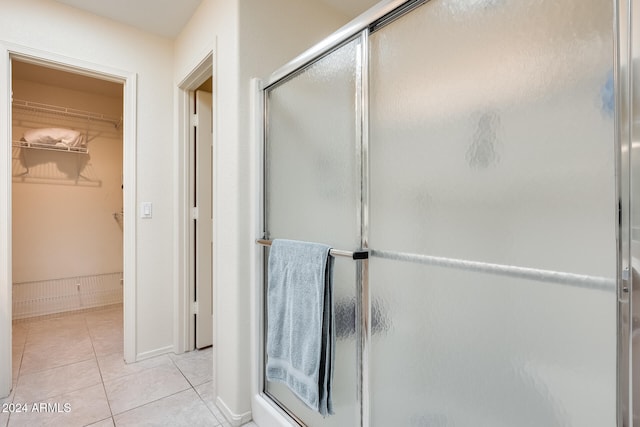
left=267, top=239, right=335, bottom=416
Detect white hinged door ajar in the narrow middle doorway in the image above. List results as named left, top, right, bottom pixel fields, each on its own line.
left=194, top=90, right=214, bottom=348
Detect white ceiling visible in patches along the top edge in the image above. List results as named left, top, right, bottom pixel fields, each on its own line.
left=55, top=0, right=379, bottom=39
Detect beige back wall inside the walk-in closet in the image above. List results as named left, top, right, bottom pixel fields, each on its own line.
left=12, top=79, right=122, bottom=283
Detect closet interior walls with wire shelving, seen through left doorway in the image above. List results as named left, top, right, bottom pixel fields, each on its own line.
left=12, top=60, right=124, bottom=328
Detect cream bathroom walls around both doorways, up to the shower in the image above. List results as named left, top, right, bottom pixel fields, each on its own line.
left=0, top=0, right=347, bottom=416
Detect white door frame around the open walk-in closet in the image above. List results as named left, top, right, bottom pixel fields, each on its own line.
left=0, top=42, right=137, bottom=397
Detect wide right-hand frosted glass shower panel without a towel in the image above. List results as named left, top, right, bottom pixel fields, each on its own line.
left=369, top=0, right=617, bottom=427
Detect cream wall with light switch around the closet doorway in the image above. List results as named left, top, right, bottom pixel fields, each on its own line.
left=0, top=0, right=174, bottom=357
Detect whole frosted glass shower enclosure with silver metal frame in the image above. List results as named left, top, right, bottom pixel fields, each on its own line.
left=256, top=0, right=640, bottom=427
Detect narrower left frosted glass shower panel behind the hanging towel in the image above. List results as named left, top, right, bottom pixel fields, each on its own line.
left=265, top=37, right=360, bottom=427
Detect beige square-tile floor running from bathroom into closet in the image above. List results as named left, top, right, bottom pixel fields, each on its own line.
left=0, top=307, right=257, bottom=427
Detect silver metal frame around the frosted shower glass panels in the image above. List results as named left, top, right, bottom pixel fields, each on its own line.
left=254, top=0, right=640, bottom=427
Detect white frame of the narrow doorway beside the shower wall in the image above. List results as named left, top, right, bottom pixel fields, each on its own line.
left=174, top=50, right=217, bottom=353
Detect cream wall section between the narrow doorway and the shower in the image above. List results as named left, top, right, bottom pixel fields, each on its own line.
left=174, top=0, right=347, bottom=421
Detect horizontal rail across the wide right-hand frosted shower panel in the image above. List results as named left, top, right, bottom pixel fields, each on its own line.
left=369, top=249, right=616, bottom=292
